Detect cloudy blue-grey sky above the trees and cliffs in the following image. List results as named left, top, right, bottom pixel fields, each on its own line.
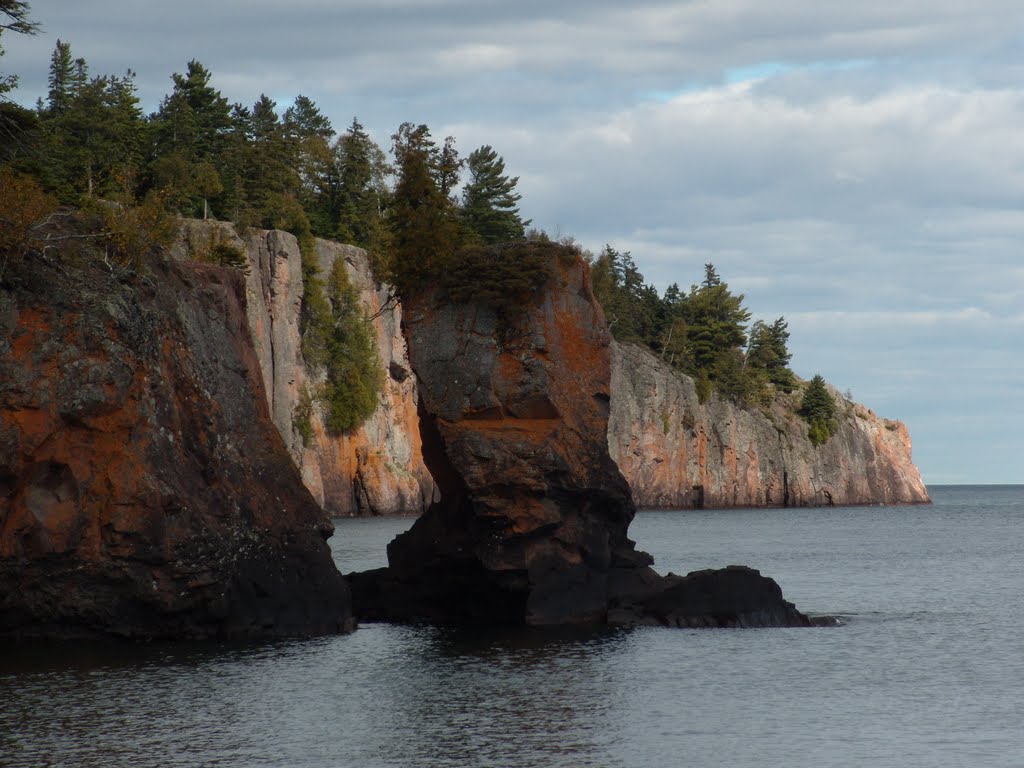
left=0, top=0, right=1024, bottom=484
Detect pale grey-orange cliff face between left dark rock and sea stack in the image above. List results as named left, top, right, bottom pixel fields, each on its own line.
left=176, top=221, right=434, bottom=516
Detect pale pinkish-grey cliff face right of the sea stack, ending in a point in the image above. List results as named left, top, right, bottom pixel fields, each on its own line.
left=608, top=343, right=929, bottom=508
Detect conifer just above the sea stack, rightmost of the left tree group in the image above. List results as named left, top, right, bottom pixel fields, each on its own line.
left=462, top=144, right=529, bottom=244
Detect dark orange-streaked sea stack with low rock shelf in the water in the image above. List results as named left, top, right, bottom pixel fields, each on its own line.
left=350, top=253, right=808, bottom=626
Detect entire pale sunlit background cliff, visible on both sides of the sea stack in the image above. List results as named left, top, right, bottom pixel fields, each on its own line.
left=176, top=220, right=928, bottom=515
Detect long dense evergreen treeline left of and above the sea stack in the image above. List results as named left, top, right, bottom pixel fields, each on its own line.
left=0, top=45, right=528, bottom=274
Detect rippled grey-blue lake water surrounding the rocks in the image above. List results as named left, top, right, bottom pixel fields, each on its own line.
left=0, top=486, right=1024, bottom=768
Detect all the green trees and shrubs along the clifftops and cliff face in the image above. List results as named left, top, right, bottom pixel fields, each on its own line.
left=0, top=9, right=835, bottom=442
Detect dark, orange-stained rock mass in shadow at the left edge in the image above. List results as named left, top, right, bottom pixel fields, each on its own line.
left=0, top=249, right=352, bottom=639
